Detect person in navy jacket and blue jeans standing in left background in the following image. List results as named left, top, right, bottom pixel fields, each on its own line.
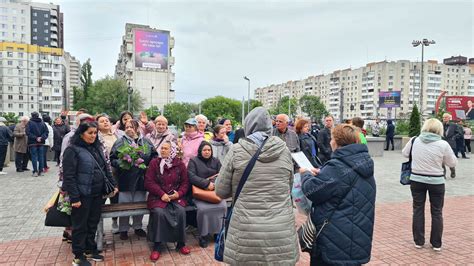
left=26, top=112, right=49, bottom=176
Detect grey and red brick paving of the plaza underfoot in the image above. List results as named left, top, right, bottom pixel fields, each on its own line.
left=0, top=151, right=474, bottom=265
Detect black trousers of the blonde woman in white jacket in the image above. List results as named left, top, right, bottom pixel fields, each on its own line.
left=410, top=181, right=445, bottom=248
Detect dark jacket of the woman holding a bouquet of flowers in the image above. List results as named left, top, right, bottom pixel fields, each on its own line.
left=110, top=136, right=157, bottom=192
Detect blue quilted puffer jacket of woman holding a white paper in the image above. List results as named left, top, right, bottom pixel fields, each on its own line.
left=302, top=144, right=376, bottom=265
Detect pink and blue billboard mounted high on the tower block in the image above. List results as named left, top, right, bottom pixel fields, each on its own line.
left=135, top=29, right=169, bottom=69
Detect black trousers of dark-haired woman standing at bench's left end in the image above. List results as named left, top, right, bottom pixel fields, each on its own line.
left=71, top=196, right=104, bottom=257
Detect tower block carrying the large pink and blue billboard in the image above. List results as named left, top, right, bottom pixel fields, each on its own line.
left=115, top=23, right=175, bottom=109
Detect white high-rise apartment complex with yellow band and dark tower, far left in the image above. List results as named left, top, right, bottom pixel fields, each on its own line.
left=0, top=0, right=74, bottom=117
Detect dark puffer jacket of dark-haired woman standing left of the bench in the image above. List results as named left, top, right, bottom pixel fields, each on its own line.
left=62, top=140, right=115, bottom=203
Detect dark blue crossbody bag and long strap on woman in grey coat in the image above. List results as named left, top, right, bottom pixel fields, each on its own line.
left=214, top=138, right=268, bottom=262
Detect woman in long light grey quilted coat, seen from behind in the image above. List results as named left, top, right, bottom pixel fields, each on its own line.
left=216, top=107, right=299, bottom=265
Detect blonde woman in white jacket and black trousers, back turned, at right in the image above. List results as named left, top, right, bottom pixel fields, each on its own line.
left=402, top=118, right=457, bottom=251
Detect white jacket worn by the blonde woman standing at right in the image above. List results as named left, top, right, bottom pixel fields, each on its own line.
left=402, top=132, right=457, bottom=185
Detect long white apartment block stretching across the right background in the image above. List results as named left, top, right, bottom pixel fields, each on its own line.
left=255, top=57, right=474, bottom=121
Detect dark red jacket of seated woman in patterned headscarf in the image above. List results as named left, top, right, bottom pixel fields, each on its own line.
left=145, top=158, right=189, bottom=209
